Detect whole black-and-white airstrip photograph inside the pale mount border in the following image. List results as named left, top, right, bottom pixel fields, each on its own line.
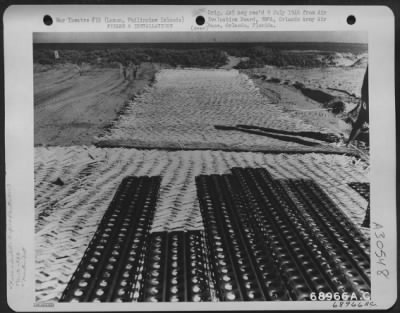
left=33, top=31, right=371, bottom=303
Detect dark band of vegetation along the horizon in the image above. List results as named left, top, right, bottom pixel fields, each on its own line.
left=33, top=43, right=367, bottom=69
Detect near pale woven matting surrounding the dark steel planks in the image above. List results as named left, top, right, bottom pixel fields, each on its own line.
left=35, top=147, right=369, bottom=301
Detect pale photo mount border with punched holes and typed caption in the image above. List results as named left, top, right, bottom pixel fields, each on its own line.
left=3, top=5, right=397, bottom=311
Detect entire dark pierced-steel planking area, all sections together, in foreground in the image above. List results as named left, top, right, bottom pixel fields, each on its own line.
left=61, top=168, right=370, bottom=302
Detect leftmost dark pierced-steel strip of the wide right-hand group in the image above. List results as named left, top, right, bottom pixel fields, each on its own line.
left=196, top=175, right=289, bottom=301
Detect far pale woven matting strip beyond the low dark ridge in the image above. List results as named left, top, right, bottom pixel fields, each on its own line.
left=96, top=69, right=346, bottom=152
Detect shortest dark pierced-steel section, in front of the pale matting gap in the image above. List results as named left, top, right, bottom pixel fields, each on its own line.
left=139, top=231, right=212, bottom=302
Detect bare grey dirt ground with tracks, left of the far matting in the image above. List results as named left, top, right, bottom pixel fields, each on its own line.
left=34, top=63, right=160, bottom=146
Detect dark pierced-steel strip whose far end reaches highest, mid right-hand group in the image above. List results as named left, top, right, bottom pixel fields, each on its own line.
left=232, top=169, right=332, bottom=300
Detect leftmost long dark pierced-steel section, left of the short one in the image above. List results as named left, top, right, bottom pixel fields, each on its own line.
left=60, top=177, right=161, bottom=302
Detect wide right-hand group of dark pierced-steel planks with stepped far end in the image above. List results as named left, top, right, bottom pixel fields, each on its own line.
left=196, top=168, right=370, bottom=300
